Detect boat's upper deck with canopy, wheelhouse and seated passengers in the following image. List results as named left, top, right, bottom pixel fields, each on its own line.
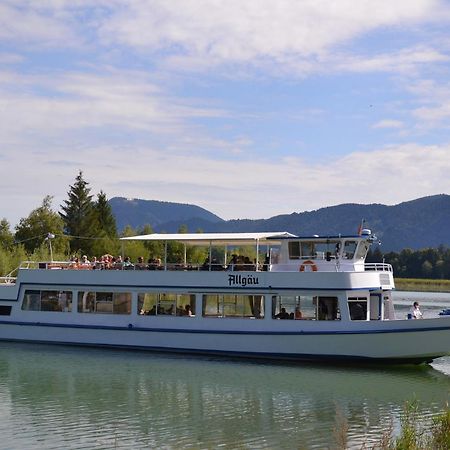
left=0, top=230, right=394, bottom=289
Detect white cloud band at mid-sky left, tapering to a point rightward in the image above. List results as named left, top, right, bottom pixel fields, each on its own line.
left=0, top=71, right=225, bottom=139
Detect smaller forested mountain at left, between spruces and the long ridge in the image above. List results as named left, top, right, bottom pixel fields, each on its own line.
left=109, top=197, right=224, bottom=233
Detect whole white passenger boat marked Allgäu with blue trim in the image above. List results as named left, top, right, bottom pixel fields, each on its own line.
left=0, top=230, right=450, bottom=363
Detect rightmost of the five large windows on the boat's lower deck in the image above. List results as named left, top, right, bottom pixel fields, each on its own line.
left=272, top=295, right=340, bottom=320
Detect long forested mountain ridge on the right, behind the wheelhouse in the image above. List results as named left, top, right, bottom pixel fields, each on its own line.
left=213, top=195, right=450, bottom=252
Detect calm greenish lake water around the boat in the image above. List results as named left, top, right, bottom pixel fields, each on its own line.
left=0, top=292, right=450, bottom=450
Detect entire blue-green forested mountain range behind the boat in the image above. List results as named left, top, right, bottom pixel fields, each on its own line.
left=111, top=194, right=450, bottom=252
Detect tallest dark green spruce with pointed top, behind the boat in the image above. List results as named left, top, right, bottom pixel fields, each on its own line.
left=59, top=170, right=98, bottom=254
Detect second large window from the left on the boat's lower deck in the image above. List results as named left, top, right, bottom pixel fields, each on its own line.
left=78, top=291, right=131, bottom=314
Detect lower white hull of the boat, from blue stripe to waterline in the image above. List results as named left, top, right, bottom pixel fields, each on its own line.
left=0, top=319, right=450, bottom=363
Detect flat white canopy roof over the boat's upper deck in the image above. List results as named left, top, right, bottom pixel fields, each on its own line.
left=120, top=231, right=297, bottom=246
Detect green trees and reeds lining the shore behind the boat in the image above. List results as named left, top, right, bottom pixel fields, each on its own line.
left=0, top=171, right=450, bottom=284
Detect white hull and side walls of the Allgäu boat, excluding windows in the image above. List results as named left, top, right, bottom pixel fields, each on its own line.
left=0, top=270, right=450, bottom=363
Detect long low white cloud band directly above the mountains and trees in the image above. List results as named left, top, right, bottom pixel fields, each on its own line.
left=0, top=140, right=450, bottom=225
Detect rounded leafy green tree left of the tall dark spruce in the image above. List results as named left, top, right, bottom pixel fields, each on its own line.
left=15, top=195, right=66, bottom=253
